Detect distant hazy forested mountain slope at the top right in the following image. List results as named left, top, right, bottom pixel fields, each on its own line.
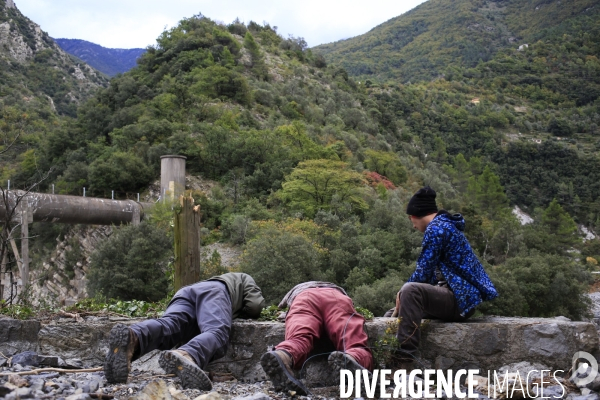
left=314, top=0, right=600, bottom=83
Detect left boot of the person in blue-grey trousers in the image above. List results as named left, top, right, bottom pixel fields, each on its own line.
left=104, top=324, right=139, bottom=383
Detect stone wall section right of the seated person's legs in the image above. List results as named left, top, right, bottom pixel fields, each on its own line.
left=421, top=317, right=598, bottom=371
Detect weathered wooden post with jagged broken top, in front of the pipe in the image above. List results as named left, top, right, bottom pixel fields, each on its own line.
left=174, top=195, right=200, bottom=290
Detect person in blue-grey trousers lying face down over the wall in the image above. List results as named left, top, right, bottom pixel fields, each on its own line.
left=104, top=273, right=265, bottom=390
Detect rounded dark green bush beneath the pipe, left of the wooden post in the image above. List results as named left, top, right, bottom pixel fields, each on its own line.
left=88, top=221, right=173, bottom=301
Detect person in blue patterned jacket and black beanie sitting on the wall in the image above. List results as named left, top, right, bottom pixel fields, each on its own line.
left=393, top=186, right=498, bottom=361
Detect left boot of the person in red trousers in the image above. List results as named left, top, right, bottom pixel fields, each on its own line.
left=260, top=350, right=310, bottom=395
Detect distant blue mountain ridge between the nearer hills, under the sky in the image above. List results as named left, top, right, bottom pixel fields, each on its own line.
left=54, top=39, right=146, bottom=76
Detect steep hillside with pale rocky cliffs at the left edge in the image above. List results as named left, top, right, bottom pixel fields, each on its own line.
left=0, top=1, right=107, bottom=191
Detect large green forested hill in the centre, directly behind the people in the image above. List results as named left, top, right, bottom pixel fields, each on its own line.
left=5, top=2, right=600, bottom=318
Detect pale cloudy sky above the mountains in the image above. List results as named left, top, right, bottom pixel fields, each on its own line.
left=14, top=0, right=424, bottom=48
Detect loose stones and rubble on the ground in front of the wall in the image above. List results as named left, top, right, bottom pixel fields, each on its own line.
left=0, top=351, right=600, bottom=400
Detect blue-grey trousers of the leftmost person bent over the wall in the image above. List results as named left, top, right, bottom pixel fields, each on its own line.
left=131, top=281, right=232, bottom=368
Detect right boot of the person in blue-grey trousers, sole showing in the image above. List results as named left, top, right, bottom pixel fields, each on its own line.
left=158, top=350, right=212, bottom=390
